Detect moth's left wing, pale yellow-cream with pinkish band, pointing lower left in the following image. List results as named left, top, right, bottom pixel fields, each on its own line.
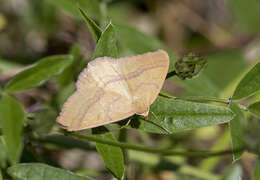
left=57, top=57, right=134, bottom=131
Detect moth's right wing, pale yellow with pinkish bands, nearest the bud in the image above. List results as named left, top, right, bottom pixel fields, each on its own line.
left=119, top=50, right=169, bottom=116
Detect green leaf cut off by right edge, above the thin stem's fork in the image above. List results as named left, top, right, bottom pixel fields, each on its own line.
left=232, top=62, right=260, bottom=100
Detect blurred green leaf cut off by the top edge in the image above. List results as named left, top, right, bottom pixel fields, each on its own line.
left=47, top=0, right=101, bottom=20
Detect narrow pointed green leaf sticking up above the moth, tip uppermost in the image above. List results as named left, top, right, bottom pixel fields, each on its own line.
left=79, top=8, right=102, bottom=42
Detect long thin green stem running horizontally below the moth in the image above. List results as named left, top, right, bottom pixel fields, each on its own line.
left=66, top=132, right=242, bottom=158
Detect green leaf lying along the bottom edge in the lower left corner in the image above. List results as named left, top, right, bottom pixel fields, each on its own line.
left=7, top=163, right=92, bottom=180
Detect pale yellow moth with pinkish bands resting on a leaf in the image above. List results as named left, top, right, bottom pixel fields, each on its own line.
left=57, top=50, right=169, bottom=131
